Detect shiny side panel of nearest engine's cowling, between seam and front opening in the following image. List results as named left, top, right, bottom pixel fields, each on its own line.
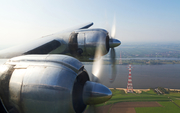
left=19, top=66, right=76, bottom=113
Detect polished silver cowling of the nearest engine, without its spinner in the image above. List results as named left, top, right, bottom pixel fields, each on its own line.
left=0, top=55, right=88, bottom=113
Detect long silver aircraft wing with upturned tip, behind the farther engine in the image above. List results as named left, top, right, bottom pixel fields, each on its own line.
left=0, top=22, right=93, bottom=58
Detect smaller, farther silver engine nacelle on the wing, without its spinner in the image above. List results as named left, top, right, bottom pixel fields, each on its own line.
left=69, top=29, right=109, bottom=58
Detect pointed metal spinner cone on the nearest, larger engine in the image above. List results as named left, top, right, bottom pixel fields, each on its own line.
left=83, top=81, right=112, bottom=105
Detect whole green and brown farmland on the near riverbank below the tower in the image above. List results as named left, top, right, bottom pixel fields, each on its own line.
left=85, top=89, right=180, bottom=113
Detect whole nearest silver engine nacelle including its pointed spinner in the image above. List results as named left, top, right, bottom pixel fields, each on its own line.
left=0, top=55, right=112, bottom=113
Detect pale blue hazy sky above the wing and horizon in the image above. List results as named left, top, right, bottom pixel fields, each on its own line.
left=0, top=0, right=180, bottom=46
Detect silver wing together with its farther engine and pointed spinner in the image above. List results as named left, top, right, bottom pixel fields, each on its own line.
left=0, top=23, right=120, bottom=62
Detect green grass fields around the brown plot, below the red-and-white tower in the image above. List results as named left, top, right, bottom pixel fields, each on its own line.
left=97, top=89, right=180, bottom=113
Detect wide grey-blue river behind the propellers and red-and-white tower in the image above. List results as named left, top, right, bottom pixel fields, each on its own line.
left=85, top=64, right=180, bottom=89
